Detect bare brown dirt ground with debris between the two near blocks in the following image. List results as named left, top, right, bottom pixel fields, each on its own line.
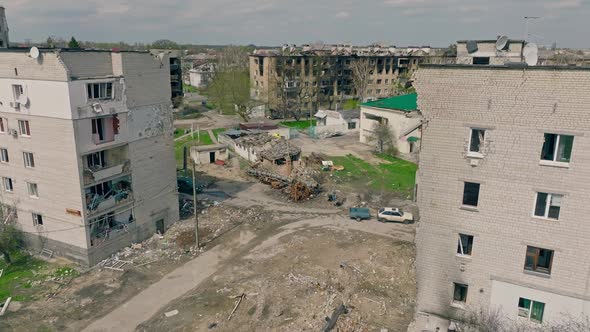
left=0, top=141, right=415, bottom=331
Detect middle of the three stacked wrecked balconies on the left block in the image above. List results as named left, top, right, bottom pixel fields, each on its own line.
left=85, top=175, right=133, bottom=216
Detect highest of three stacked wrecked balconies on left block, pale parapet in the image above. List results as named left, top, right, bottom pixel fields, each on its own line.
left=82, top=145, right=129, bottom=186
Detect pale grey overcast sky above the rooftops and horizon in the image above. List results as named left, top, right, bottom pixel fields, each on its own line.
left=3, top=0, right=590, bottom=47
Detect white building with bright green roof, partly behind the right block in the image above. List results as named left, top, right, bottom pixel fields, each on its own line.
left=360, top=93, right=422, bottom=155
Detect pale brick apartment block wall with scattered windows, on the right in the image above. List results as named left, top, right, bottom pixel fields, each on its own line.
left=414, top=65, right=590, bottom=331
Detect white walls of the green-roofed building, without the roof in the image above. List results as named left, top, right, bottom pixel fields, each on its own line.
left=360, top=106, right=421, bottom=154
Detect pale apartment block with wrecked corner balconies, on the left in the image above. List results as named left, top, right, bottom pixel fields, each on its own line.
left=0, top=48, right=178, bottom=265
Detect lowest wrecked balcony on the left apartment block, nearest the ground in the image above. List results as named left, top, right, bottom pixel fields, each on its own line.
left=88, top=209, right=135, bottom=247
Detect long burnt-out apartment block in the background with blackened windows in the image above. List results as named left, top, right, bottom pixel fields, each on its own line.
left=249, top=45, right=454, bottom=115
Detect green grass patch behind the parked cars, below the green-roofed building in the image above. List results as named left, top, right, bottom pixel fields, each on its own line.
left=330, top=155, right=418, bottom=197
